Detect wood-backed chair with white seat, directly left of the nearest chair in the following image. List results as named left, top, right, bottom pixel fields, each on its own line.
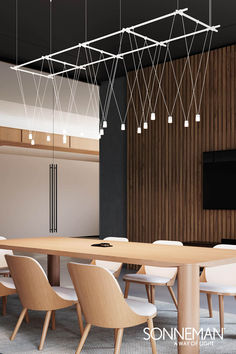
left=5, top=255, right=83, bottom=350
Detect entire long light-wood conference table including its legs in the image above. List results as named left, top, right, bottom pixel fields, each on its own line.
left=0, top=236, right=236, bottom=354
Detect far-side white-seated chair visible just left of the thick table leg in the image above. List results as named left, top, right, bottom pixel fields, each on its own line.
left=123, top=240, right=183, bottom=308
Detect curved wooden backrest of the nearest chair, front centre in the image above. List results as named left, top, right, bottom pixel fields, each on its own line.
left=67, top=262, right=144, bottom=328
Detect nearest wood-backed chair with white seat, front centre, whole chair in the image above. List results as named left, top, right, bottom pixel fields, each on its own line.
left=68, top=263, right=156, bottom=354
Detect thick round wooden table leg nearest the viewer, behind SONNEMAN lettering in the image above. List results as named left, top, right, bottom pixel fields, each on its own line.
left=178, top=264, right=200, bottom=354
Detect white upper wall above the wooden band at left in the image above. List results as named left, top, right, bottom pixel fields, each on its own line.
left=0, top=62, right=99, bottom=139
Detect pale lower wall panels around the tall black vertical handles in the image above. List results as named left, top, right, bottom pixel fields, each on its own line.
left=0, top=154, right=99, bottom=238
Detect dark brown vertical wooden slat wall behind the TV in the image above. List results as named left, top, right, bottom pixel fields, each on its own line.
left=127, top=45, right=236, bottom=242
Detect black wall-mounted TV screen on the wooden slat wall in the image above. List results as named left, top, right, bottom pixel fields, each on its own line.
left=203, top=150, right=236, bottom=209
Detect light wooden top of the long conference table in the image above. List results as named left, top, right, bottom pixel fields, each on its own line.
left=0, top=236, right=236, bottom=267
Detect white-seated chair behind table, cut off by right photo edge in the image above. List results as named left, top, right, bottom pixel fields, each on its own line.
left=200, top=244, right=236, bottom=334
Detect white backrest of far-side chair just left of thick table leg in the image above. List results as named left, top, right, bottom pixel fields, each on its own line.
left=145, top=240, right=183, bottom=278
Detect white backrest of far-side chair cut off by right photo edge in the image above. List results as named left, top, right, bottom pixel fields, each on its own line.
left=205, top=244, right=236, bottom=286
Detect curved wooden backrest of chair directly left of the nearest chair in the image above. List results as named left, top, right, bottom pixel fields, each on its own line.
left=5, top=255, right=72, bottom=311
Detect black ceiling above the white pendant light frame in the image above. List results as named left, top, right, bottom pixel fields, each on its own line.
left=0, top=0, right=236, bottom=81
